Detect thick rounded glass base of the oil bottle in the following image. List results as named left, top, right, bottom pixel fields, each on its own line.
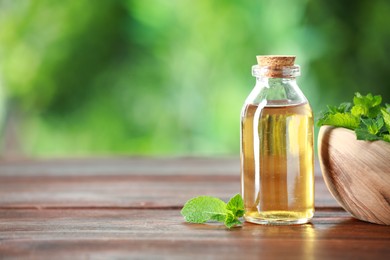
left=244, top=210, right=314, bottom=225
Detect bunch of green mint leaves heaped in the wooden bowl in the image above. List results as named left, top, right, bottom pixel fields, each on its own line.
left=317, top=93, right=390, bottom=142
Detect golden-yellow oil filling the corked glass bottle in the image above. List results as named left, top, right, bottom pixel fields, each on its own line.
left=241, top=100, right=314, bottom=224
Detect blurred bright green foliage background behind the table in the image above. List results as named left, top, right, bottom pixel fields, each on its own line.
left=0, top=0, right=390, bottom=157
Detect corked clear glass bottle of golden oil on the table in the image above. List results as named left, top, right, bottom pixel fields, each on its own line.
left=241, top=56, right=314, bottom=225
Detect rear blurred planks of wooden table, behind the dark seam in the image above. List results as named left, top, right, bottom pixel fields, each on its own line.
left=0, top=158, right=338, bottom=209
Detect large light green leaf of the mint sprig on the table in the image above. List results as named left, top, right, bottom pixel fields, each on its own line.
left=181, top=196, right=227, bottom=223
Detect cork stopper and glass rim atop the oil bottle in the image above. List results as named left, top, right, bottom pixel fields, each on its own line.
left=252, top=55, right=300, bottom=78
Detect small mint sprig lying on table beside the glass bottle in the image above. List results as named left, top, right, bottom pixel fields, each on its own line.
left=181, top=194, right=245, bottom=228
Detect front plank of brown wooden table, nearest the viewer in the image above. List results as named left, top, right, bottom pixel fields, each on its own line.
left=0, top=209, right=390, bottom=259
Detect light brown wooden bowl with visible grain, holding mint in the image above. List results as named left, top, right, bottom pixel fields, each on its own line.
left=318, top=126, right=390, bottom=225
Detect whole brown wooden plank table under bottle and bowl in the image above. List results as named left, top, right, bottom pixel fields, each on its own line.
left=0, top=158, right=390, bottom=259
